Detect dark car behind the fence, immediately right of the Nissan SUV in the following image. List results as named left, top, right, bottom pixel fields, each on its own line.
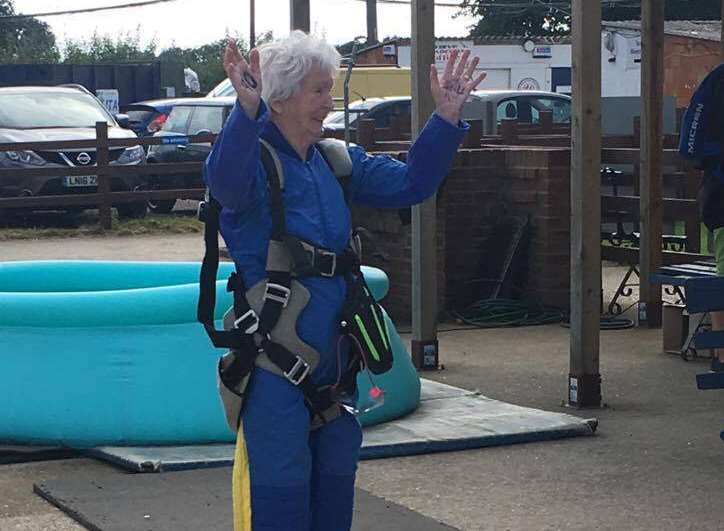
left=147, top=97, right=236, bottom=213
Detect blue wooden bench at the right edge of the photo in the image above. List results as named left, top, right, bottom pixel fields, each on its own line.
left=684, top=276, right=724, bottom=440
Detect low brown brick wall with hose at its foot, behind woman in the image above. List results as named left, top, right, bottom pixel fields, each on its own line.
left=353, top=147, right=570, bottom=322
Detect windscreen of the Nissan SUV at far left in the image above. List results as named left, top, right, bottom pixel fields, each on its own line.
left=0, top=92, right=116, bottom=129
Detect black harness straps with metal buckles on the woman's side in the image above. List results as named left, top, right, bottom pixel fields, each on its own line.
left=197, top=139, right=359, bottom=424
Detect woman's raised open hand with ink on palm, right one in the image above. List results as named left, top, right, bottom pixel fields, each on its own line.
left=430, top=50, right=487, bottom=126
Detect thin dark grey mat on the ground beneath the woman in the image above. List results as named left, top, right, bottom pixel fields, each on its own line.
left=33, top=469, right=454, bottom=531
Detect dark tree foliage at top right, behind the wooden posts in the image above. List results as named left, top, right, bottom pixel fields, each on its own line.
left=461, top=0, right=721, bottom=37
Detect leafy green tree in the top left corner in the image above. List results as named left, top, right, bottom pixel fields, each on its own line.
left=0, top=0, right=60, bottom=63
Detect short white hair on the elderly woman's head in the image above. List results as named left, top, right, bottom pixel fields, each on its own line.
left=259, top=30, right=341, bottom=103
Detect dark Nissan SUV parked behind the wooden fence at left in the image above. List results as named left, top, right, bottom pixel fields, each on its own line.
left=0, top=86, right=146, bottom=217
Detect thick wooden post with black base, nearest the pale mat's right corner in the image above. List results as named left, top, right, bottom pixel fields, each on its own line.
left=568, top=0, right=601, bottom=407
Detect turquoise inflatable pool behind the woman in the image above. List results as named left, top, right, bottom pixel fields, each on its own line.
left=0, top=261, right=420, bottom=447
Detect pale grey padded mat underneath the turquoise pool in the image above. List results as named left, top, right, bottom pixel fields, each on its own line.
left=89, top=380, right=597, bottom=472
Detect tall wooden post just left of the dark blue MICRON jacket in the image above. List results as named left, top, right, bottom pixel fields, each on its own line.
left=639, top=0, right=664, bottom=328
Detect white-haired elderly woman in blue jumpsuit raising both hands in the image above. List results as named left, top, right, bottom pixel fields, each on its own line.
left=204, top=31, right=484, bottom=531
